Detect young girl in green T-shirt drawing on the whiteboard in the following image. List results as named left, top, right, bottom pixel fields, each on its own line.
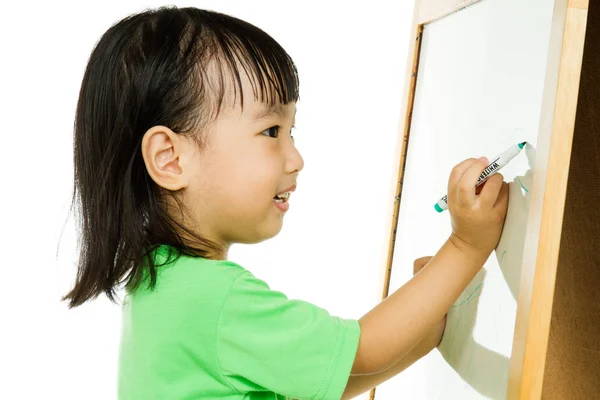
left=64, top=7, right=507, bottom=400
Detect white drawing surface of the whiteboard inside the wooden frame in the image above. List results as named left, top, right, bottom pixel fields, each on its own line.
left=375, top=0, right=554, bottom=400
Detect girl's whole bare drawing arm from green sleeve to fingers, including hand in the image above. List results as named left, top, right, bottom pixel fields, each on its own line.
left=351, top=159, right=508, bottom=375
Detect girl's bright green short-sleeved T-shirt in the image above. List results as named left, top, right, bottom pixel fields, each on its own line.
left=118, top=246, right=360, bottom=400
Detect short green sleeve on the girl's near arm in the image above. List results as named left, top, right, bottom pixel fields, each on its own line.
left=217, top=271, right=360, bottom=400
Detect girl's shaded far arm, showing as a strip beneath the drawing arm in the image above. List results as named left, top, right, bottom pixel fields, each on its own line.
left=342, top=314, right=446, bottom=400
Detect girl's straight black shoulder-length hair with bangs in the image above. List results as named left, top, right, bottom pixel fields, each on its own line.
left=62, top=6, right=299, bottom=308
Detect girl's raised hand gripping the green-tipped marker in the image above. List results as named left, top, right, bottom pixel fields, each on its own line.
left=448, top=157, right=508, bottom=258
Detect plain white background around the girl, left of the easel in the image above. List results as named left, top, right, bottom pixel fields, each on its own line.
left=0, top=0, right=414, bottom=400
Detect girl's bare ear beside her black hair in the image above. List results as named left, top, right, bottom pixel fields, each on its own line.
left=142, top=125, right=188, bottom=191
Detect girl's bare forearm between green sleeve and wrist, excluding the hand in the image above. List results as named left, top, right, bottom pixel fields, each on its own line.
left=352, top=240, right=487, bottom=374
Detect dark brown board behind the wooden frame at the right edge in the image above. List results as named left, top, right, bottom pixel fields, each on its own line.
left=542, top=1, right=600, bottom=400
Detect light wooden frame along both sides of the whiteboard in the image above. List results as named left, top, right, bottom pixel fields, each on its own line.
left=370, top=0, right=589, bottom=400
